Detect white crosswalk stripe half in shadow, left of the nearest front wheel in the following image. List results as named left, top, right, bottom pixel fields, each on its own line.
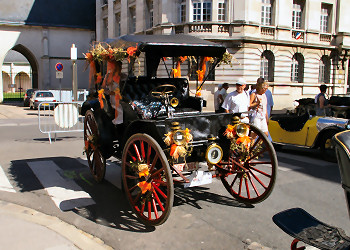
left=27, top=161, right=95, bottom=211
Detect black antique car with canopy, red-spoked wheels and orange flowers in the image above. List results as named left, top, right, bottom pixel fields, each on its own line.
left=81, top=35, right=277, bottom=226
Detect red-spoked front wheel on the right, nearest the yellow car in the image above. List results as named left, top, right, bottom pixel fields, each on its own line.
left=216, top=125, right=278, bottom=204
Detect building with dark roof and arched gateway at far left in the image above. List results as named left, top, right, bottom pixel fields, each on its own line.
left=0, top=0, right=96, bottom=102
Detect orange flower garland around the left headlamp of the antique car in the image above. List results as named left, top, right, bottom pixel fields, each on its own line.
left=164, top=128, right=193, bottom=160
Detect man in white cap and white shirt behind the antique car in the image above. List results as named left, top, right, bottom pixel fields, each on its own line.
left=222, top=78, right=249, bottom=123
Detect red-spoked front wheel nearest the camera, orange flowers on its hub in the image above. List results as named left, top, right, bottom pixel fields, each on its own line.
left=122, top=134, right=174, bottom=226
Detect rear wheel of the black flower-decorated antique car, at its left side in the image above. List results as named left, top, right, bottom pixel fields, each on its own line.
left=84, top=110, right=106, bottom=182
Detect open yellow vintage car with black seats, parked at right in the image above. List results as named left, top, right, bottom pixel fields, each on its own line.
left=269, top=99, right=350, bottom=162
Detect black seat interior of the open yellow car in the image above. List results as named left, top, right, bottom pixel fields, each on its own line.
left=271, top=112, right=309, bottom=132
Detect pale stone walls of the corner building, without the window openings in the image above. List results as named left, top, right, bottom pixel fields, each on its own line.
left=96, top=0, right=350, bottom=110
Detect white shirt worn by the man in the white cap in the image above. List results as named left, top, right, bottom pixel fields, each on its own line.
left=222, top=90, right=250, bottom=113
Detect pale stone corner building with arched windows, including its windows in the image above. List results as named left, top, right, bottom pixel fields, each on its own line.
left=96, top=0, right=350, bottom=110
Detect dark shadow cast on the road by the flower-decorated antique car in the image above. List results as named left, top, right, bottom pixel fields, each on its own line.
left=9, top=157, right=254, bottom=232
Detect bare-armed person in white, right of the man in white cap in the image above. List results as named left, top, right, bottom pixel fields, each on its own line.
left=249, top=80, right=269, bottom=136
